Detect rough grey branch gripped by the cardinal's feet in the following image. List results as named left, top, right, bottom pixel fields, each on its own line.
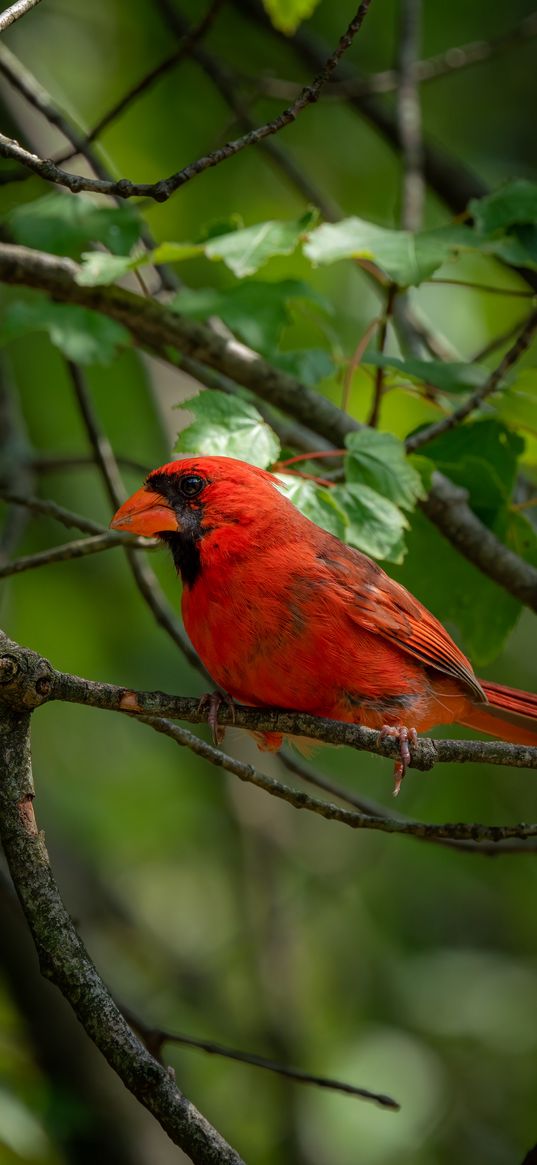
left=0, top=631, right=537, bottom=778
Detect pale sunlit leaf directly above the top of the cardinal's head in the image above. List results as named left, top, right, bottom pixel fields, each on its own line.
left=175, top=389, right=280, bottom=469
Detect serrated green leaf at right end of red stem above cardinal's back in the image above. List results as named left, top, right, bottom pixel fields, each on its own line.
left=345, top=429, right=425, bottom=510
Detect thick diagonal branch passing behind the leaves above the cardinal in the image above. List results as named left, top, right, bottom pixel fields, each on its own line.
left=0, top=245, right=537, bottom=610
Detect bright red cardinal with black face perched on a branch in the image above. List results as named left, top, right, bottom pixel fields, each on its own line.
left=112, top=457, right=537, bottom=790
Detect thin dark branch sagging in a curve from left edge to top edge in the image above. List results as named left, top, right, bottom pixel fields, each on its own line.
left=0, top=0, right=372, bottom=203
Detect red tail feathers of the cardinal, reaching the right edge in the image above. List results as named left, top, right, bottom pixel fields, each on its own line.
left=464, top=680, right=537, bottom=746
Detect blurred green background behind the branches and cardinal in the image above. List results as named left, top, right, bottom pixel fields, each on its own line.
left=0, top=0, right=537, bottom=1165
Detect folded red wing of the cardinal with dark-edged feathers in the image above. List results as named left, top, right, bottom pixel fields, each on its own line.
left=318, top=538, right=486, bottom=700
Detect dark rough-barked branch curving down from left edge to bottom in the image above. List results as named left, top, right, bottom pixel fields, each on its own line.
left=0, top=701, right=243, bottom=1165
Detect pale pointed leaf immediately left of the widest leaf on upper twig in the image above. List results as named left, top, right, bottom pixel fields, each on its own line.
left=204, top=210, right=318, bottom=278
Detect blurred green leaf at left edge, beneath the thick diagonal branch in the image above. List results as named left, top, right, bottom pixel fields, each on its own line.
left=0, top=295, right=130, bottom=363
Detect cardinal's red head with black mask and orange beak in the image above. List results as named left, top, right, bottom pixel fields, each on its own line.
left=111, top=457, right=282, bottom=584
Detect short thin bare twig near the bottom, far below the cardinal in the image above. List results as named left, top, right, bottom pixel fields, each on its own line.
left=121, top=1008, right=401, bottom=1110
